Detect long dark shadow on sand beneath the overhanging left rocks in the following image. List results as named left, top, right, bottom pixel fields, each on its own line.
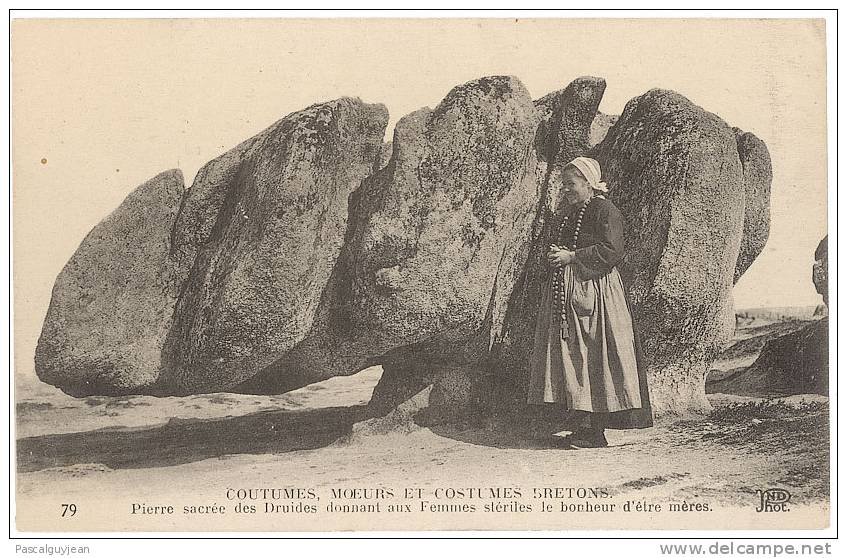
left=17, top=405, right=370, bottom=473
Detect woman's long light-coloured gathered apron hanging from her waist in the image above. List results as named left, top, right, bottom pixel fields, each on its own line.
left=527, top=265, right=652, bottom=416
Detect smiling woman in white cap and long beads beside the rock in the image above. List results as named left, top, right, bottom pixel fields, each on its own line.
left=527, top=157, right=653, bottom=447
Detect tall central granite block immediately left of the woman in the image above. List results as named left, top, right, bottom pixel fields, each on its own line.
left=238, top=76, right=539, bottom=400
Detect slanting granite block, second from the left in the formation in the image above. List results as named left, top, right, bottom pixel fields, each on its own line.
left=158, top=98, right=388, bottom=393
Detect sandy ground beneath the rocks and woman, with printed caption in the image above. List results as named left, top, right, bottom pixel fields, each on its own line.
left=16, top=318, right=829, bottom=531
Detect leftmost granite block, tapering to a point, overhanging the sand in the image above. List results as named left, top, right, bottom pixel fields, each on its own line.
left=35, top=170, right=185, bottom=396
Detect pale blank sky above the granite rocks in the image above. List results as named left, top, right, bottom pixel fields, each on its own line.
left=12, top=19, right=827, bottom=374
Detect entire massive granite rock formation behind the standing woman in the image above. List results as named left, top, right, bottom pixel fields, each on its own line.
left=38, top=76, right=770, bottom=424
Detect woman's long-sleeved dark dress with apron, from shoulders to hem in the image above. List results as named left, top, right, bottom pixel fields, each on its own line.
left=527, top=196, right=653, bottom=428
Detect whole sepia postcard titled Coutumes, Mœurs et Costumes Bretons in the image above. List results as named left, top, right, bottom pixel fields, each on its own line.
left=11, top=13, right=835, bottom=536
